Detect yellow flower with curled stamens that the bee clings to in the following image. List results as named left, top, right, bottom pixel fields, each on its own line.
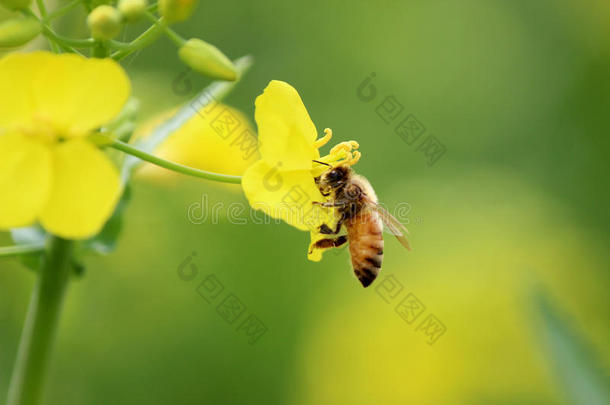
left=242, top=80, right=360, bottom=261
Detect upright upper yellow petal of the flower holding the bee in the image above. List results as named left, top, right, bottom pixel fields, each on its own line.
left=255, top=80, right=320, bottom=170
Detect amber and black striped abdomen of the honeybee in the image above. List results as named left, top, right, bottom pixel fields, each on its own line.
left=345, top=209, right=383, bottom=287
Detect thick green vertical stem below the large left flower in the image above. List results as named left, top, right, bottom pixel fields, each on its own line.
left=7, top=236, right=72, bottom=405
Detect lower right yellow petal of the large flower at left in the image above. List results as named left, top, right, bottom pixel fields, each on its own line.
left=40, top=139, right=120, bottom=239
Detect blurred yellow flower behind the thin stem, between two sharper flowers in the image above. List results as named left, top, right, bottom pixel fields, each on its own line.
left=136, top=103, right=259, bottom=180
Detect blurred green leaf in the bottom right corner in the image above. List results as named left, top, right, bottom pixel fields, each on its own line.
left=536, top=293, right=610, bottom=405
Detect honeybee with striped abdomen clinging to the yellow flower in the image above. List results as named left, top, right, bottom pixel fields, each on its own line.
left=312, top=161, right=411, bottom=287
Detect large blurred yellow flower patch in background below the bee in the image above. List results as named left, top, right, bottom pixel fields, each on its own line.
left=286, top=176, right=610, bottom=405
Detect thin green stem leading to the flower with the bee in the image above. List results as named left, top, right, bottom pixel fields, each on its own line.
left=89, top=134, right=241, bottom=184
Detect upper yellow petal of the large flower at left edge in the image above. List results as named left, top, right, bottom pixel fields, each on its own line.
left=0, top=51, right=131, bottom=137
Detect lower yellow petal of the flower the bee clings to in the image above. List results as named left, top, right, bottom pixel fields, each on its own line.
left=242, top=160, right=334, bottom=231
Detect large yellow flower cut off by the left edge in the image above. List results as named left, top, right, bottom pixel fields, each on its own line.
left=0, top=52, right=130, bottom=239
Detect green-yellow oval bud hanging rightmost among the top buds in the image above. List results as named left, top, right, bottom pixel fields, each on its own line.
left=178, top=38, right=237, bottom=81
